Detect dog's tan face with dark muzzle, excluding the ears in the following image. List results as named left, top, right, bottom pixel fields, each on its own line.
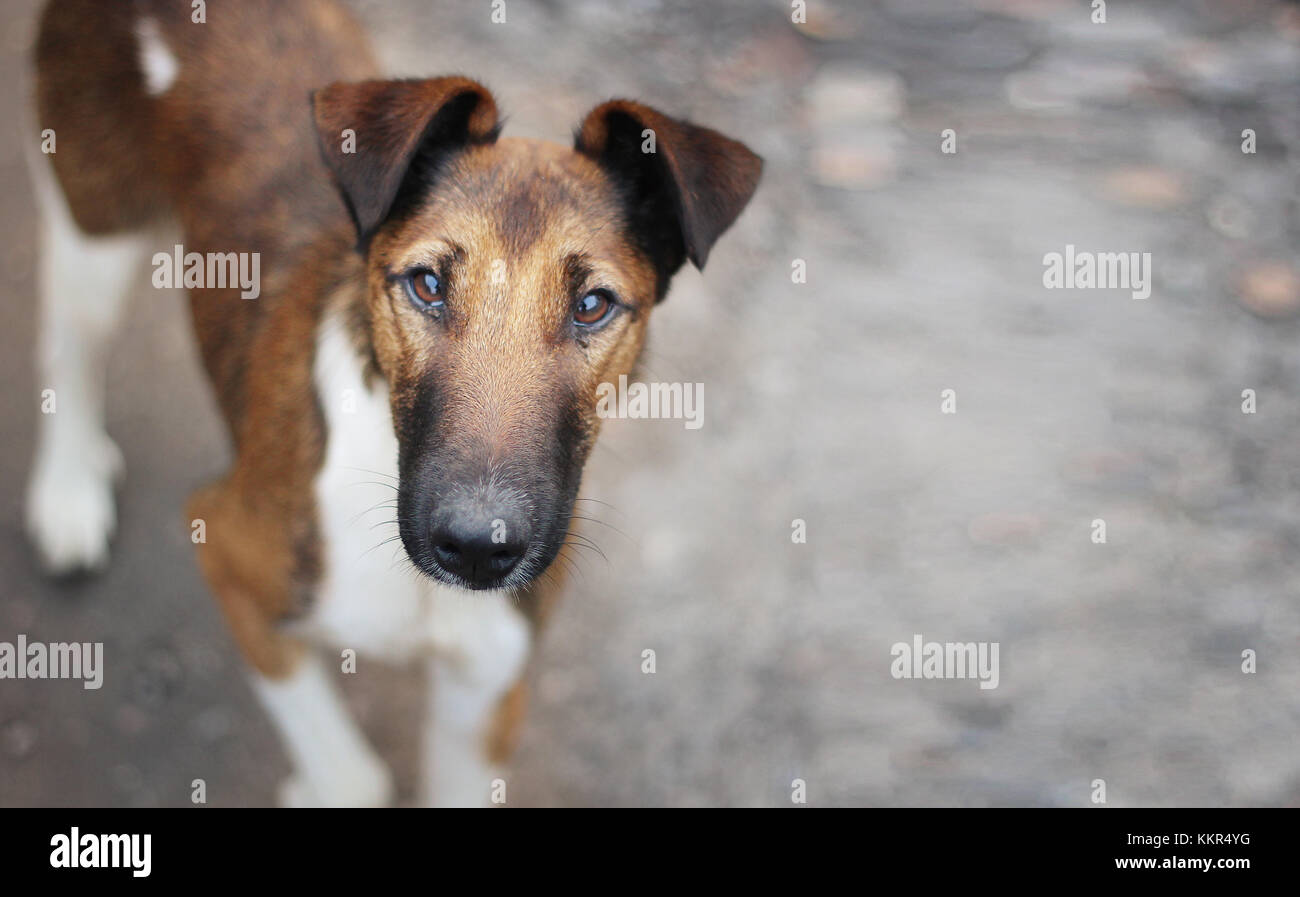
left=368, top=140, right=655, bottom=588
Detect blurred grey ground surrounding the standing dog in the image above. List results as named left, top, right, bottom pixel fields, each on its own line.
left=0, top=0, right=1300, bottom=806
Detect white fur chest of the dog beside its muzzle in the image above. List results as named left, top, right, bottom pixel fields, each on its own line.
left=306, top=310, right=428, bottom=652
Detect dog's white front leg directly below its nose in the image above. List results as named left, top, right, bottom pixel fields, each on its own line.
left=421, top=589, right=532, bottom=807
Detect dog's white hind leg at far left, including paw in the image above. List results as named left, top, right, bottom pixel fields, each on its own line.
left=26, top=143, right=151, bottom=573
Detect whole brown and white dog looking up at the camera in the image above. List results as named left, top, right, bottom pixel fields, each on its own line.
left=27, top=0, right=762, bottom=805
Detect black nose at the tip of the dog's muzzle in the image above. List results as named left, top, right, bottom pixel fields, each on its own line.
left=429, top=502, right=530, bottom=589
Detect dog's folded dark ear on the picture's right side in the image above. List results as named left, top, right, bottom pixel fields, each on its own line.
left=575, top=100, right=763, bottom=288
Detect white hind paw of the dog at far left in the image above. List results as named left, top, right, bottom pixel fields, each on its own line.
left=27, top=436, right=122, bottom=575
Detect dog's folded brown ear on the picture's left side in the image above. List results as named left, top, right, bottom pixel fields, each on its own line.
left=312, top=77, right=499, bottom=246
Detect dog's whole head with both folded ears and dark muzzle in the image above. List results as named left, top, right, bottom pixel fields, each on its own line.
left=313, top=78, right=762, bottom=589
